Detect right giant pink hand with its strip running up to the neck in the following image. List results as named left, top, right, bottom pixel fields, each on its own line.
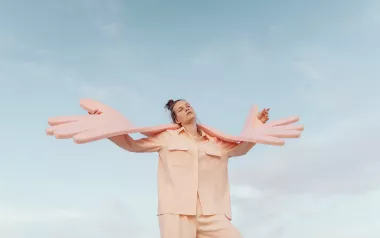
left=201, top=105, right=304, bottom=146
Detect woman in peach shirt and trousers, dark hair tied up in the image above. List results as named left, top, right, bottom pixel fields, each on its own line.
left=90, top=99, right=269, bottom=238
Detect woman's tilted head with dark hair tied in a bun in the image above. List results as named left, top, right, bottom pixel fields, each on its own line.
left=165, top=99, right=196, bottom=125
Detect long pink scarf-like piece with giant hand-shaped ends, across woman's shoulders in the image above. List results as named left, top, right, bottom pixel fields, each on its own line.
left=47, top=99, right=303, bottom=145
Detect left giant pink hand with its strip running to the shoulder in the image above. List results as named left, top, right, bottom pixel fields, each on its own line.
left=46, top=99, right=178, bottom=144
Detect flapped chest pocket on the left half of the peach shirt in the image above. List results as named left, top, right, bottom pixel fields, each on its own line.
left=167, top=143, right=192, bottom=167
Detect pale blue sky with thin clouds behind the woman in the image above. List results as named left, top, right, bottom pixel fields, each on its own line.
left=0, top=0, right=380, bottom=238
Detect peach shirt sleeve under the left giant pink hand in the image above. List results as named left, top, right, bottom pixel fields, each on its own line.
left=109, top=131, right=167, bottom=153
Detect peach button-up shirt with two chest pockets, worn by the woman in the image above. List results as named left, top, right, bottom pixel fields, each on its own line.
left=111, top=127, right=254, bottom=219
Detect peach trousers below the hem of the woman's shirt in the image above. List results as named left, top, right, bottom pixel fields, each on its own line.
left=158, top=194, right=242, bottom=238
